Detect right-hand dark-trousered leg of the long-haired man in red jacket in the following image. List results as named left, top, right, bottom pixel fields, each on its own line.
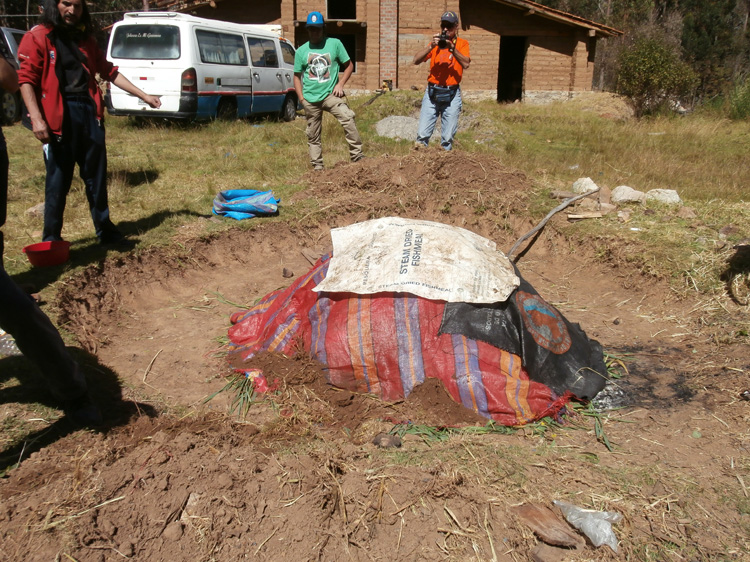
left=73, top=101, right=123, bottom=243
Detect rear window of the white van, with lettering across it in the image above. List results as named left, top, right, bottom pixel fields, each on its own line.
left=111, top=25, right=180, bottom=60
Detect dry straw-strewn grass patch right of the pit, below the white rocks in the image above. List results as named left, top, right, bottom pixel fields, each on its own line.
left=558, top=195, right=750, bottom=343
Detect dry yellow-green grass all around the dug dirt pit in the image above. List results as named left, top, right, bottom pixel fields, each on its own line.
left=4, top=91, right=750, bottom=302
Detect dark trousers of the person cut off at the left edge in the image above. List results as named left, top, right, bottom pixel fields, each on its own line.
left=0, top=148, right=86, bottom=401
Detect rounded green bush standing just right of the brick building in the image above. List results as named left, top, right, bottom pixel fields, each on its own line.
left=617, top=37, right=697, bottom=117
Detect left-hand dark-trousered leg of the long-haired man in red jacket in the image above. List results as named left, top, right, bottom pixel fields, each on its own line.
left=42, top=137, right=75, bottom=242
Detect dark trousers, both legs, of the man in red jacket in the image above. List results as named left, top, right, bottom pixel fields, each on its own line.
left=42, top=96, right=121, bottom=242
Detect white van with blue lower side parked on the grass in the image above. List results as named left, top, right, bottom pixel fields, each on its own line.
left=105, top=12, right=298, bottom=121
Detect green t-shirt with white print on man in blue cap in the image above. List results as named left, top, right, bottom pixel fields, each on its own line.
left=294, top=37, right=349, bottom=103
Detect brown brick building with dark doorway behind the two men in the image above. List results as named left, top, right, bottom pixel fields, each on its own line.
left=151, top=0, right=622, bottom=101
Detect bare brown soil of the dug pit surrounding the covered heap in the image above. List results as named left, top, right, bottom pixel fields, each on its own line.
left=0, top=150, right=750, bottom=562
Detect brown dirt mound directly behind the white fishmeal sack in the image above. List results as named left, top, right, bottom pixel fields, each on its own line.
left=293, top=148, right=531, bottom=241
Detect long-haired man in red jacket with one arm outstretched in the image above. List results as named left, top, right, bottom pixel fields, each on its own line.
left=18, top=0, right=161, bottom=245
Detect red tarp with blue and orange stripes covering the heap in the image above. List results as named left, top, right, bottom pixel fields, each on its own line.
left=229, top=256, right=571, bottom=426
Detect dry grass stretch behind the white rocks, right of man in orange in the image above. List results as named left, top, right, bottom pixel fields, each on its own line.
left=470, top=98, right=750, bottom=202
